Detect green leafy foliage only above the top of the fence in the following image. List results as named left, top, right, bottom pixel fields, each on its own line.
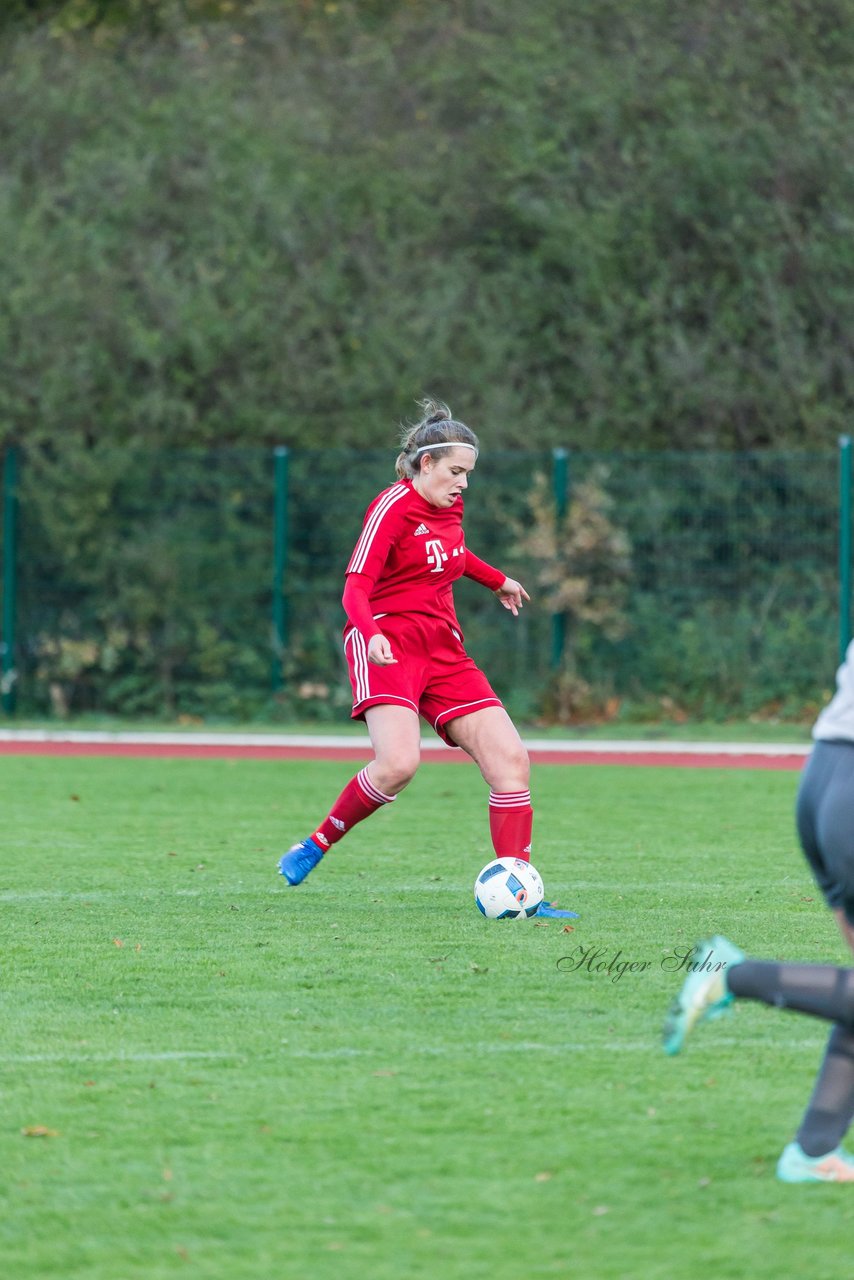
left=0, top=0, right=854, bottom=449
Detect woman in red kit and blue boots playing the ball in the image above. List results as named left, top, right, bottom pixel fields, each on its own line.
left=279, top=401, right=574, bottom=915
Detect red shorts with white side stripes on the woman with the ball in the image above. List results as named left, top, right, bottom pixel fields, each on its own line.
left=344, top=613, right=503, bottom=746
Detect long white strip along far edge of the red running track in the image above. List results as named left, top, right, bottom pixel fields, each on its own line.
left=0, top=728, right=810, bottom=758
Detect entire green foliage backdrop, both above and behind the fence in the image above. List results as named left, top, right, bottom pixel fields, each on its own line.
left=0, top=0, right=854, bottom=719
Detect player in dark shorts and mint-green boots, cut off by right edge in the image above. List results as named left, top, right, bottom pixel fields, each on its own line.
left=665, top=643, right=854, bottom=1183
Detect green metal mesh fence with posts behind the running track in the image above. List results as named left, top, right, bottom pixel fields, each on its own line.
left=0, top=438, right=851, bottom=721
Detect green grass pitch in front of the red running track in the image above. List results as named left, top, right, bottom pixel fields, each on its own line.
left=0, top=758, right=854, bottom=1280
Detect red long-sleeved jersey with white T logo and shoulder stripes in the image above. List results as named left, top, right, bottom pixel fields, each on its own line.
left=344, top=480, right=504, bottom=641
